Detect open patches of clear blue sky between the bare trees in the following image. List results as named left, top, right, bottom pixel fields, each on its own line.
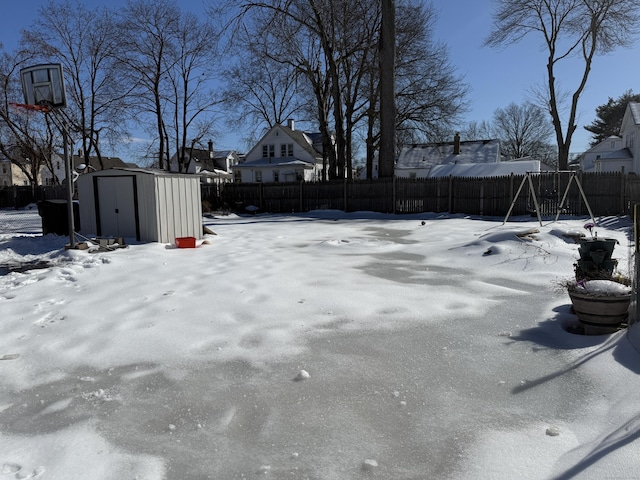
left=0, top=0, right=640, bottom=153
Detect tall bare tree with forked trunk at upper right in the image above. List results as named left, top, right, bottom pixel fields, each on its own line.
left=485, top=0, right=640, bottom=170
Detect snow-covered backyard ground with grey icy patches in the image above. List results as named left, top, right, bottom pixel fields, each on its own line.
left=0, top=210, right=640, bottom=480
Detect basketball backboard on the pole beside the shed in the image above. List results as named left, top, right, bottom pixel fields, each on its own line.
left=20, top=63, right=67, bottom=108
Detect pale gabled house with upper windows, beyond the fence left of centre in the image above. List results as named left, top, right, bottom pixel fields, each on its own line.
left=233, top=120, right=322, bottom=183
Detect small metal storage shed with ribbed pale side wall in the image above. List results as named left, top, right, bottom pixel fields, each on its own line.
left=77, top=168, right=202, bottom=243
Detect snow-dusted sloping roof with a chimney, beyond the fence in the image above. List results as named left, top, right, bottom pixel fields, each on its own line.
left=396, top=140, right=500, bottom=169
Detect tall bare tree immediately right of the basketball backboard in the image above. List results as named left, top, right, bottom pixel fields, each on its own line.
left=22, top=1, right=128, bottom=170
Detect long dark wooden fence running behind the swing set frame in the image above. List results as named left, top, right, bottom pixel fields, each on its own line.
left=220, top=172, right=640, bottom=216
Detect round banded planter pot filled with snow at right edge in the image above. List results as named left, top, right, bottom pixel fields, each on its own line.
left=569, top=291, right=631, bottom=335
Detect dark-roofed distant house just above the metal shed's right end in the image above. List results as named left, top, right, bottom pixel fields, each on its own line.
left=170, top=141, right=240, bottom=184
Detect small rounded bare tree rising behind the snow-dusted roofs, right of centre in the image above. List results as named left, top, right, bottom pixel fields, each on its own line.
left=493, top=103, right=553, bottom=159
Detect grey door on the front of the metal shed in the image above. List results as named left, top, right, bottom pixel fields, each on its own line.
left=97, top=176, right=138, bottom=239
